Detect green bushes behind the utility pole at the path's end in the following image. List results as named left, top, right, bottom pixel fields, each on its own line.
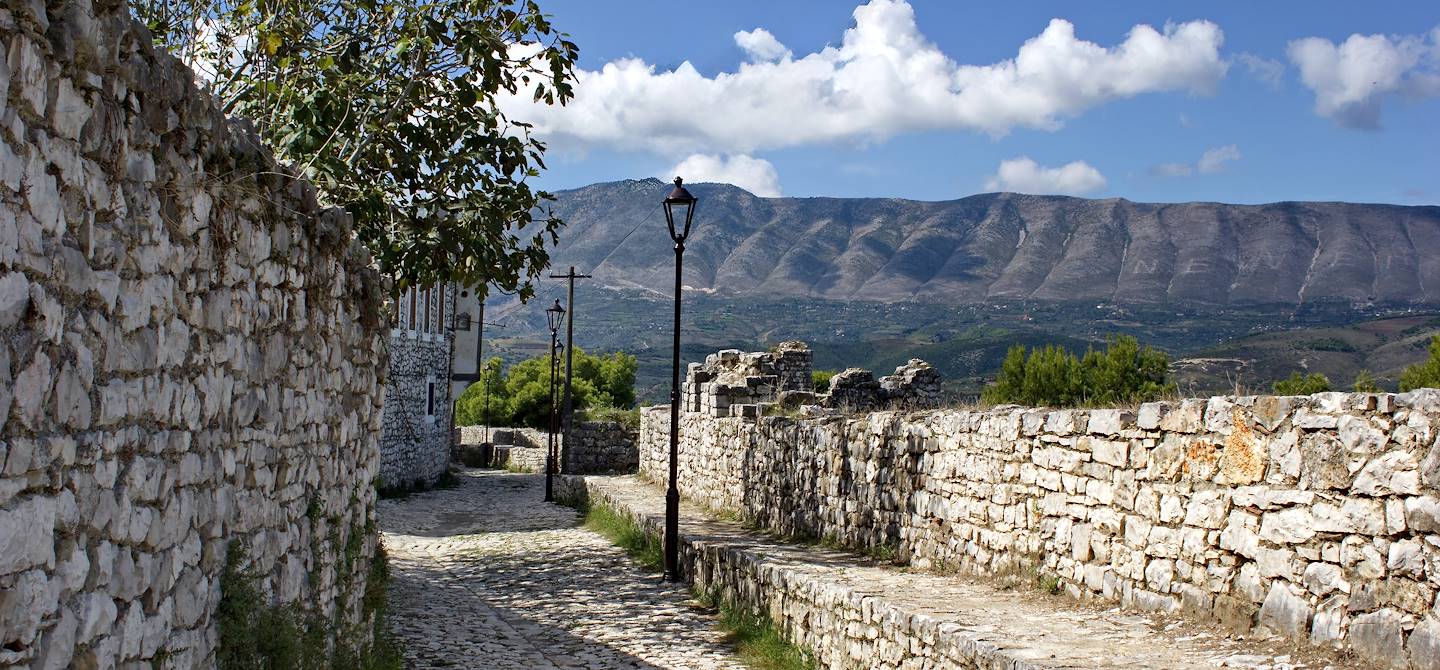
left=455, top=347, right=636, bottom=428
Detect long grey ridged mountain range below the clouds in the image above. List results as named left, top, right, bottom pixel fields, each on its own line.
left=553, top=179, right=1440, bottom=310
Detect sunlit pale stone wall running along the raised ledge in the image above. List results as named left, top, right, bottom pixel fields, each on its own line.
left=639, top=389, right=1440, bottom=667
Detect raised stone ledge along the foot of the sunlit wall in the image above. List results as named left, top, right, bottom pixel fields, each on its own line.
left=562, top=477, right=1352, bottom=670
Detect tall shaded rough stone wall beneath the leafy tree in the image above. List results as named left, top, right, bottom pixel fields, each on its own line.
left=0, top=1, right=386, bottom=669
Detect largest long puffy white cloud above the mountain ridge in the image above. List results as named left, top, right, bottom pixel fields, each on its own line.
left=505, top=0, right=1227, bottom=153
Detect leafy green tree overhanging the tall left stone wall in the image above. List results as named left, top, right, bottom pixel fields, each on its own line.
left=132, top=0, right=579, bottom=297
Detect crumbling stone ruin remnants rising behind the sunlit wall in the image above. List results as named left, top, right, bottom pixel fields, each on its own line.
left=680, top=341, right=943, bottom=416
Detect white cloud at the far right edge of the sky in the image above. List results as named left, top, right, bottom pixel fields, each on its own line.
left=1287, top=26, right=1440, bottom=128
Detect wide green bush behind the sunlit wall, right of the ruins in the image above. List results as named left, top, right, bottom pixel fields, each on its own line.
left=982, top=336, right=1175, bottom=406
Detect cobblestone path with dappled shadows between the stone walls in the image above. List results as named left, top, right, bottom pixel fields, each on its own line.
left=380, top=470, right=743, bottom=670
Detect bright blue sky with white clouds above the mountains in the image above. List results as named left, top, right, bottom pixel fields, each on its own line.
left=507, top=0, right=1440, bottom=205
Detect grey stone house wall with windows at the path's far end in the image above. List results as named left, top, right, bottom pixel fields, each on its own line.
left=380, top=285, right=456, bottom=487
